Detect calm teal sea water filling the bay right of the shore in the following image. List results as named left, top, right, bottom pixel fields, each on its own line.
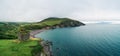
left=36, top=24, right=120, bottom=56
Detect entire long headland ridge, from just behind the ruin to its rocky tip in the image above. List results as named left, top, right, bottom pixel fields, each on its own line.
left=22, top=17, right=85, bottom=30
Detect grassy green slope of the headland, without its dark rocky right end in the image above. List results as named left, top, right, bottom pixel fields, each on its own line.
left=22, top=18, right=65, bottom=30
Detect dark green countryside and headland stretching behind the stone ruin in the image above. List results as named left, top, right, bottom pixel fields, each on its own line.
left=0, top=17, right=85, bottom=39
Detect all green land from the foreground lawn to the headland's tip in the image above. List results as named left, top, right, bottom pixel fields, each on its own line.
left=0, top=17, right=85, bottom=56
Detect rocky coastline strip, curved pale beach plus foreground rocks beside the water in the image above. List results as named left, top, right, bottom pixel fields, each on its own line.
left=30, top=25, right=85, bottom=56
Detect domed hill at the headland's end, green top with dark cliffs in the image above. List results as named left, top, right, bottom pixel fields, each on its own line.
left=38, top=17, right=85, bottom=28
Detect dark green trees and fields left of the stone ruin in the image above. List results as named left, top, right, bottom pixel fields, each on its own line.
left=0, top=22, right=19, bottom=39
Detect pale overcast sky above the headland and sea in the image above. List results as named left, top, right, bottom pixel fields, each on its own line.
left=0, top=0, right=120, bottom=22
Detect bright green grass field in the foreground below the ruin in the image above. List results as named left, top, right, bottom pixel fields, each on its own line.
left=0, top=40, right=37, bottom=56
